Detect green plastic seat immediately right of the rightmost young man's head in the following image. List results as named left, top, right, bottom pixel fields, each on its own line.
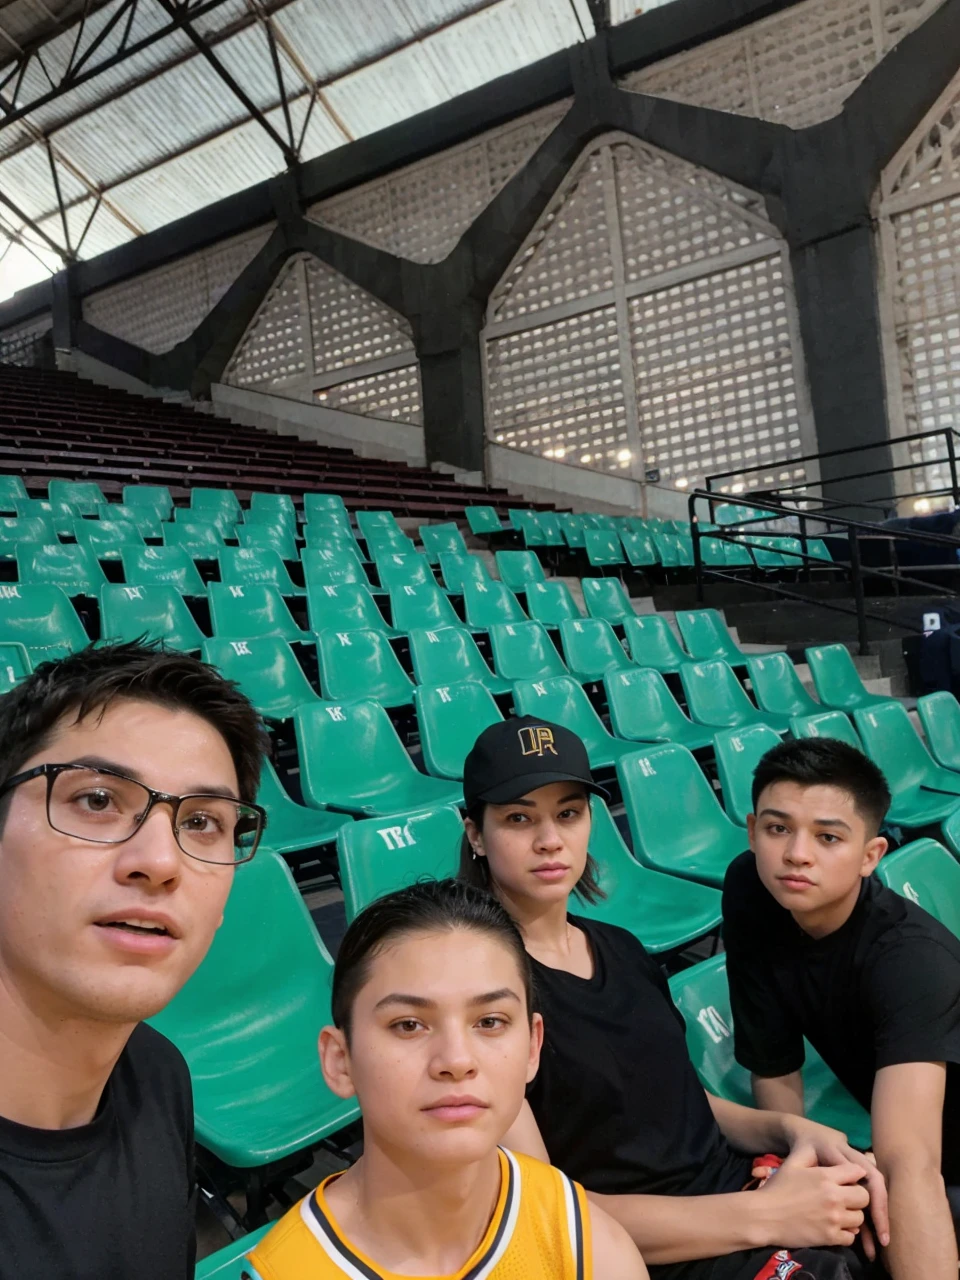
left=854, top=701, right=960, bottom=827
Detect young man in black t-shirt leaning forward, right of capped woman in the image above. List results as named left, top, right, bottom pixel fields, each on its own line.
left=723, top=739, right=960, bottom=1280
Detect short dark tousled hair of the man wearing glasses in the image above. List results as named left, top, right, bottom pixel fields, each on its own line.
left=0, top=641, right=269, bottom=818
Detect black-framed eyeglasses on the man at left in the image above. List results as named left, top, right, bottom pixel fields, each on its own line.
left=0, top=764, right=266, bottom=867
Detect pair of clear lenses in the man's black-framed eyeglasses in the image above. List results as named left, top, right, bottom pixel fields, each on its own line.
left=49, top=769, right=260, bottom=863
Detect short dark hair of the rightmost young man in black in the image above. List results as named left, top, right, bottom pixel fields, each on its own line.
left=753, top=737, right=891, bottom=833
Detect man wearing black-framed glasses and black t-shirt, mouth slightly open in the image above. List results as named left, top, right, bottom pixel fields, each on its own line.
left=0, top=644, right=266, bottom=1280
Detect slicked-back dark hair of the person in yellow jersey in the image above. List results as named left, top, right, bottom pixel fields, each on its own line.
left=330, top=879, right=535, bottom=1038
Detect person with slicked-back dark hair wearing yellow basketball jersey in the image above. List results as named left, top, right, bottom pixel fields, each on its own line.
left=244, top=881, right=648, bottom=1280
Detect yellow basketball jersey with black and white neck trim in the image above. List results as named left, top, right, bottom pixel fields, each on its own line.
left=242, top=1151, right=593, bottom=1280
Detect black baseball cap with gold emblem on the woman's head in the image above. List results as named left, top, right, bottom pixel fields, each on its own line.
left=463, top=716, right=609, bottom=809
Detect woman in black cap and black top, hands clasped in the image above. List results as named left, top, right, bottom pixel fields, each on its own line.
left=461, top=716, right=886, bottom=1280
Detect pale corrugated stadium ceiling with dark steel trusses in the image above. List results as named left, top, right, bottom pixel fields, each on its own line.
left=0, top=0, right=668, bottom=300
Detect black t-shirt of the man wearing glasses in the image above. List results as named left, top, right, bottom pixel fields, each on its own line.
left=0, top=1025, right=196, bottom=1280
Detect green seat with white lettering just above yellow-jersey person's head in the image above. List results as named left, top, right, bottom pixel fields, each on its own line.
left=337, top=805, right=463, bottom=920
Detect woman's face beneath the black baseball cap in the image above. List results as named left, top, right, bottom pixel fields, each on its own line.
left=466, top=782, right=590, bottom=905
